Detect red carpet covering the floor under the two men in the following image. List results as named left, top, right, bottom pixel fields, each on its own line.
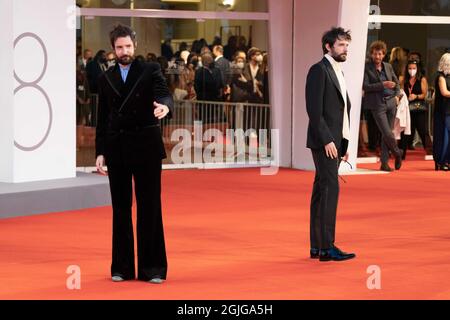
left=0, top=161, right=450, bottom=299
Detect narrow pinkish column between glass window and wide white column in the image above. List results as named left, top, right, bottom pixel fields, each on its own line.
left=268, top=0, right=298, bottom=167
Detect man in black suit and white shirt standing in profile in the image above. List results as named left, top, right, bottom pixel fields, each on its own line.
left=306, top=28, right=355, bottom=261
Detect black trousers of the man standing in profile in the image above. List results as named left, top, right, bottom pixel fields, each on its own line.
left=310, top=149, right=340, bottom=249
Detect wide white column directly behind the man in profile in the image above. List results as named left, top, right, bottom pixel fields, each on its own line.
left=293, top=0, right=369, bottom=170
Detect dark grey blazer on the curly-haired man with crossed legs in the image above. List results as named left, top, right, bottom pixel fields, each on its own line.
left=363, top=62, right=400, bottom=110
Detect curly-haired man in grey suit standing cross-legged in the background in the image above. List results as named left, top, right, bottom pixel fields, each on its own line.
left=363, top=41, right=402, bottom=172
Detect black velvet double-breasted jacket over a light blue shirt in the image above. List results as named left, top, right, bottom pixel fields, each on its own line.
left=96, top=60, right=173, bottom=164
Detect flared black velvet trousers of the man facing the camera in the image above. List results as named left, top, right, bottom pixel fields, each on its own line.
left=108, top=160, right=167, bottom=281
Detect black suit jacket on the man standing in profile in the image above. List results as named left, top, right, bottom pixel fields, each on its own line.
left=306, top=57, right=351, bottom=155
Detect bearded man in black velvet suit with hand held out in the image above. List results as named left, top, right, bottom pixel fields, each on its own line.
left=96, top=25, right=173, bottom=283
